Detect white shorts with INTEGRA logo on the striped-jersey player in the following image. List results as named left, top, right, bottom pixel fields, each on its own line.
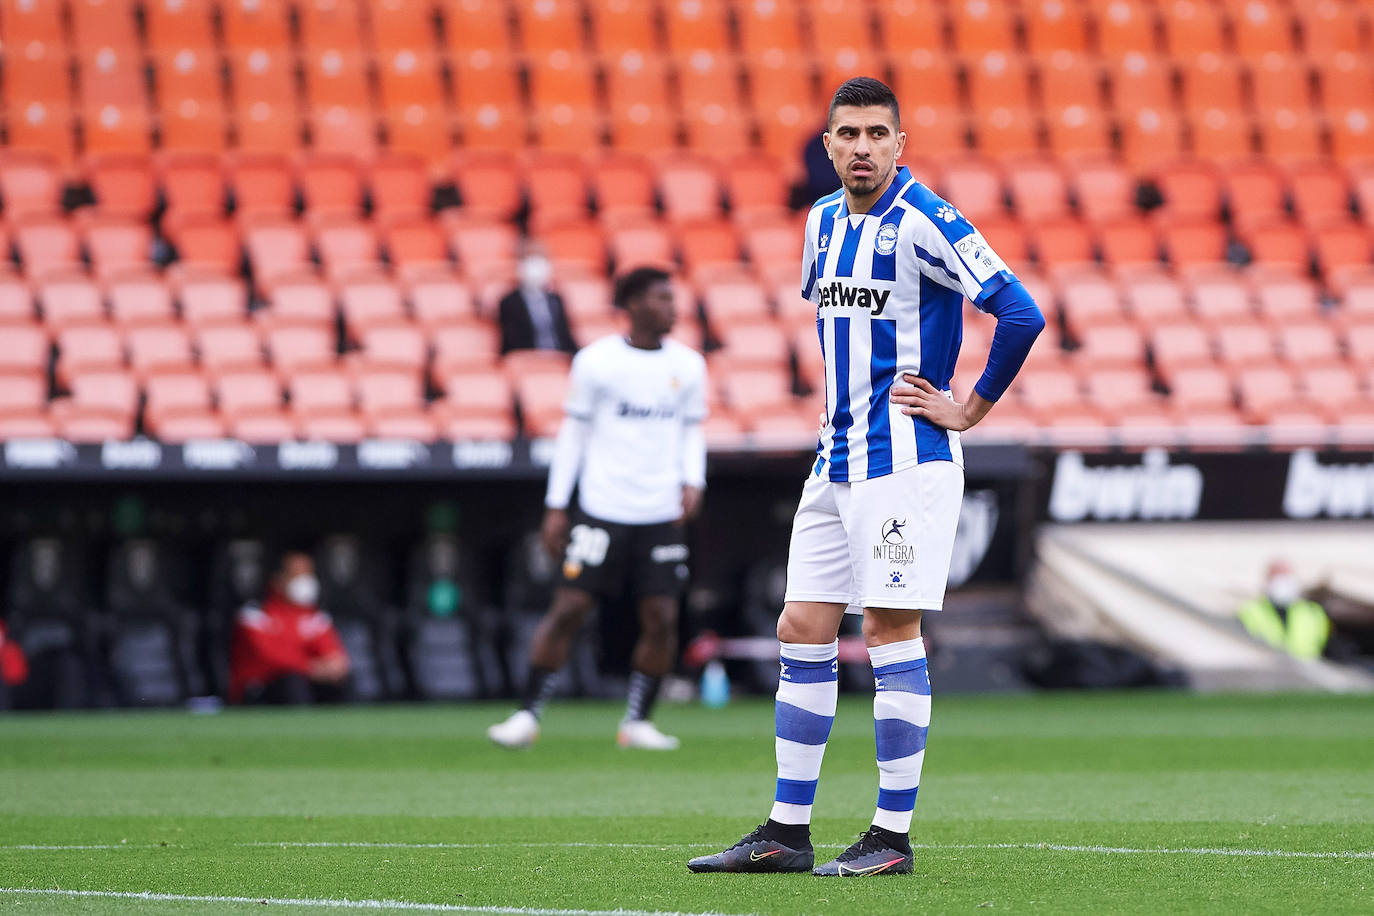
left=785, top=461, right=963, bottom=614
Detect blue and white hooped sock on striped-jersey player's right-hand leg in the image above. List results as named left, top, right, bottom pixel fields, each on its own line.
left=868, top=639, right=930, bottom=834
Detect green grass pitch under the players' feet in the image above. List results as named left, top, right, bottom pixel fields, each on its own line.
left=0, top=694, right=1374, bottom=916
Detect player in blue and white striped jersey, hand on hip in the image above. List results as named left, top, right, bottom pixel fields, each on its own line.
left=688, top=77, right=1044, bottom=876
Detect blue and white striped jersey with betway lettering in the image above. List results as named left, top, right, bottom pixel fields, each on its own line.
left=801, top=168, right=1015, bottom=481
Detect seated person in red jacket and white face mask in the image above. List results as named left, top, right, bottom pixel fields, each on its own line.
left=229, top=552, right=349, bottom=703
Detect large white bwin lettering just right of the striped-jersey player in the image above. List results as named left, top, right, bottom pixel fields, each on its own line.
left=1050, top=449, right=1202, bottom=522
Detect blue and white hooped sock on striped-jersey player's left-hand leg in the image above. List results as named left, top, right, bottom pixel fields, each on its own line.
left=769, top=640, right=840, bottom=824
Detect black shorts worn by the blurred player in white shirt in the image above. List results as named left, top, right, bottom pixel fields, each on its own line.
left=563, top=511, right=690, bottom=597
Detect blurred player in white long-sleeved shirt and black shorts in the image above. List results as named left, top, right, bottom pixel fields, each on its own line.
left=486, top=268, right=706, bottom=750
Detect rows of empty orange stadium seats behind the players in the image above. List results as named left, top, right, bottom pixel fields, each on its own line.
left=0, top=0, right=1374, bottom=445
